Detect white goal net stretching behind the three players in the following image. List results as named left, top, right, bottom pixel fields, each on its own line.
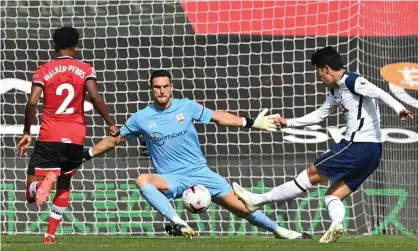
left=0, top=0, right=418, bottom=236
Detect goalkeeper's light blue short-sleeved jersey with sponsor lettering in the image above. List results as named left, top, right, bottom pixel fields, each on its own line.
left=121, top=99, right=213, bottom=174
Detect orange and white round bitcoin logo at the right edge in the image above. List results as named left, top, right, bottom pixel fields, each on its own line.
left=380, top=63, right=418, bottom=108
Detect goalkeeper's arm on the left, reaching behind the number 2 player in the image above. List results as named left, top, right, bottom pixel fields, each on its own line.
left=83, top=114, right=141, bottom=162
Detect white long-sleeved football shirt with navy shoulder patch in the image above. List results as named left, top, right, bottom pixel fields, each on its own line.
left=287, top=71, right=405, bottom=142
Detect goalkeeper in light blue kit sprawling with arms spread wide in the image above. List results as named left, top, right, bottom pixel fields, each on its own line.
left=84, top=70, right=310, bottom=239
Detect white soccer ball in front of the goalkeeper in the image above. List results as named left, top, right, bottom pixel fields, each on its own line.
left=183, top=185, right=212, bottom=214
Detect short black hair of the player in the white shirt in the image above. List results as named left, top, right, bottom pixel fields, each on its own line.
left=311, top=46, right=344, bottom=71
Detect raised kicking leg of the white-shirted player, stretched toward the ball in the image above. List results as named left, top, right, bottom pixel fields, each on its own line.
left=233, top=140, right=353, bottom=212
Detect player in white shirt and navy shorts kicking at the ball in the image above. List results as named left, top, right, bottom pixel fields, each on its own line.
left=233, top=46, right=413, bottom=243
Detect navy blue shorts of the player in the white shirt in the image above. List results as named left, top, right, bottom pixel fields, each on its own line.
left=314, top=139, right=382, bottom=191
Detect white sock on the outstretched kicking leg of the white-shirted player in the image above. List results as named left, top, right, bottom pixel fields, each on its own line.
left=251, top=170, right=312, bottom=206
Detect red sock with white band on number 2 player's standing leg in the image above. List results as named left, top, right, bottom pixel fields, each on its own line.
left=46, top=190, right=70, bottom=236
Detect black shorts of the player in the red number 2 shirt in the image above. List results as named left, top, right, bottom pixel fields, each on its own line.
left=28, top=141, right=84, bottom=176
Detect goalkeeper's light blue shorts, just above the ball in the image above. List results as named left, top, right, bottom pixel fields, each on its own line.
left=158, top=167, right=232, bottom=201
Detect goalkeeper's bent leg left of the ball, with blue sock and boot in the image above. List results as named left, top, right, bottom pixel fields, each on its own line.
left=136, top=173, right=194, bottom=238
